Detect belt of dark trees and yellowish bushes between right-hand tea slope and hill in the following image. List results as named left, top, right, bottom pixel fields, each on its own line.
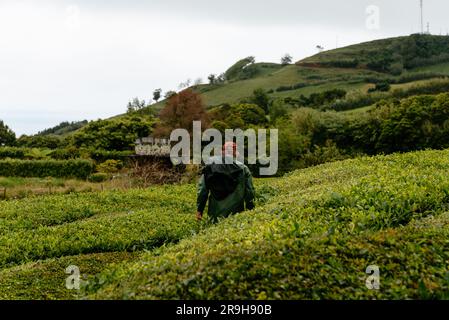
left=276, top=94, right=449, bottom=173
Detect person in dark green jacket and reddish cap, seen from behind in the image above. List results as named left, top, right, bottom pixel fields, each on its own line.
left=196, top=142, right=254, bottom=222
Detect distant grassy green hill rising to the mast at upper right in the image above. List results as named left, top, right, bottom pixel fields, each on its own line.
left=143, top=35, right=449, bottom=110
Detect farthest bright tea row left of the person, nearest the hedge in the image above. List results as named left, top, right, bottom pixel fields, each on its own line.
left=0, top=186, right=195, bottom=234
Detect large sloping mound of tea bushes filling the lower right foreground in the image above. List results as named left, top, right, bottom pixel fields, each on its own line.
left=85, top=150, right=449, bottom=299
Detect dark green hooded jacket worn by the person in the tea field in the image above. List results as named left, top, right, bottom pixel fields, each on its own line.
left=197, top=158, right=255, bottom=222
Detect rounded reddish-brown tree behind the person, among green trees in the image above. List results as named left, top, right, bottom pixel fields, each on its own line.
left=154, top=89, right=209, bottom=137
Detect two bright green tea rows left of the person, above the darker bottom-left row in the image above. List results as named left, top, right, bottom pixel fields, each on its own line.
left=0, top=186, right=201, bottom=268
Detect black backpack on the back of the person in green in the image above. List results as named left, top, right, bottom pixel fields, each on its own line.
left=203, top=163, right=243, bottom=201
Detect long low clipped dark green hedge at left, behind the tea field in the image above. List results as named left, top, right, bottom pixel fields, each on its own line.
left=0, top=160, right=95, bottom=179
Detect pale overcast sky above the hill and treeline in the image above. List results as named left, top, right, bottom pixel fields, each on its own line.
left=0, top=0, right=449, bottom=135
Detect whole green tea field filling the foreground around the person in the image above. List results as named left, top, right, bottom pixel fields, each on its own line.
left=0, top=150, right=449, bottom=299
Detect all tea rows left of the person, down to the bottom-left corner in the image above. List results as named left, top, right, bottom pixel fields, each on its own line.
left=0, top=185, right=202, bottom=299
